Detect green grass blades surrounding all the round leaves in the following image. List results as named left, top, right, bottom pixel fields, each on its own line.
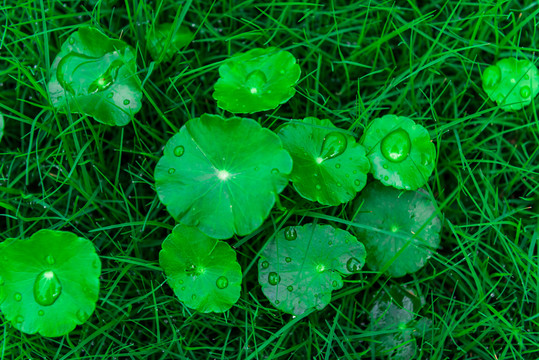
left=0, top=0, right=539, bottom=359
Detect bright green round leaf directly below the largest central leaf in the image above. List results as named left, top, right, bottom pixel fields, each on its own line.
left=159, top=224, right=242, bottom=313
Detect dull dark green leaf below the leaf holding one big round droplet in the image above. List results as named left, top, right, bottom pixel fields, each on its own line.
left=354, top=183, right=442, bottom=277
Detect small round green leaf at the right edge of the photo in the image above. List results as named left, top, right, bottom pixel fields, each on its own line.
left=483, top=58, right=539, bottom=111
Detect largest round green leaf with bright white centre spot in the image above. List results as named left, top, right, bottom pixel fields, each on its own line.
left=155, top=114, right=292, bottom=239
